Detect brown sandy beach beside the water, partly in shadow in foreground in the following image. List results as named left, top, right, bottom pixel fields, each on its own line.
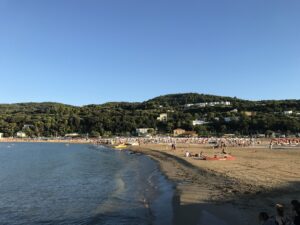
left=133, top=144, right=300, bottom=225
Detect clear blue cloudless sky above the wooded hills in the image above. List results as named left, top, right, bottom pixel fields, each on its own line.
left=0, top=0, right=300, bottom=105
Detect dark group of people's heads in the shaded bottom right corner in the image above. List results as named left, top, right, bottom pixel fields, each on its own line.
left=258, top=200, right=300, bottom=225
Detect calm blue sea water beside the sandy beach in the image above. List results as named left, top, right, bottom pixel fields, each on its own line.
left=0, top=143, right=173, bottom=225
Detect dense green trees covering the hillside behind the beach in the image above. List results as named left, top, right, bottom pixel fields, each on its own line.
left=0, top=93, right=300, bottom=137
